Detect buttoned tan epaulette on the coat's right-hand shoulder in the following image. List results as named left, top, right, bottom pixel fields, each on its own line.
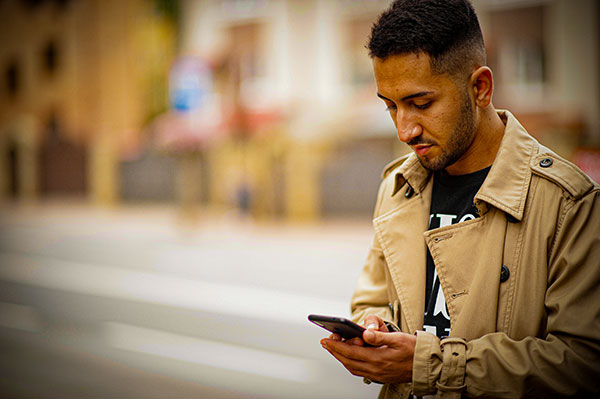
left=529, top=152, right=594, bottom=199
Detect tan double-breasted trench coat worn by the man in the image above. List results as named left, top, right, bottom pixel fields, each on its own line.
left=352, top=111, right=600, bottom=398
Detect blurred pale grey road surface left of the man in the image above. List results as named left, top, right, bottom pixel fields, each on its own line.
left=0, top=204, right=379, bottom=399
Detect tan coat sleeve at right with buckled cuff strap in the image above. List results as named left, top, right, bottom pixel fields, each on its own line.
left=413, top=188, right=600, bottom=398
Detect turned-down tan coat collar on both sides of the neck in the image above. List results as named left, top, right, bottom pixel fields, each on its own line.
left=392, top=110, right=537, bottom=220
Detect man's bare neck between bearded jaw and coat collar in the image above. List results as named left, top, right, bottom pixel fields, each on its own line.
left=446, top=105, right=504, bottom=175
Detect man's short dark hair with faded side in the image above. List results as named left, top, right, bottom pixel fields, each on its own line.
left=367, top=0, right=486, bottom=80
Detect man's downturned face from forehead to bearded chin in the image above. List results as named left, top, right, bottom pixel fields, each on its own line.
left=373, top=53, right=476, bottom=170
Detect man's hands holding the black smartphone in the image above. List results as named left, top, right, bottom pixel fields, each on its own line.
left=321, top=316, right=417, bottom=383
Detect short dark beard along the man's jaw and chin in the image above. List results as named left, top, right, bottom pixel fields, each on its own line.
left=408, top=93, right=476, bottom=172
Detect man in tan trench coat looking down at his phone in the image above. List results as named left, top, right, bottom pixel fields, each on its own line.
left=321, top=0, right=600, bottom=398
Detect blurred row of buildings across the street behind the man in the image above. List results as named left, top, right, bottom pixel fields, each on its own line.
left=0, top=0, right=600, bottom=219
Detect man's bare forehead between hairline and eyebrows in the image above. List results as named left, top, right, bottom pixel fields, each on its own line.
left=373, top=53, right=454, bottom=98
